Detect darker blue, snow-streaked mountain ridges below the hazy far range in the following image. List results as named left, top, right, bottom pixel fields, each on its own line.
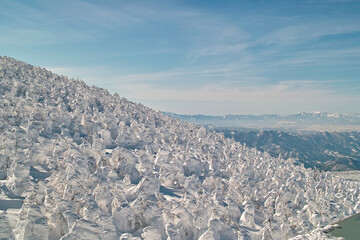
left=215, top=128, right=360, bottom=171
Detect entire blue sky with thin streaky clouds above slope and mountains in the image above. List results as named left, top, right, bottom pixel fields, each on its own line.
left=0, top=0, right=360, bottom=115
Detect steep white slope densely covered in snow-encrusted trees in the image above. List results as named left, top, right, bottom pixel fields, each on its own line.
left=0, top=57, right=360, bottom=240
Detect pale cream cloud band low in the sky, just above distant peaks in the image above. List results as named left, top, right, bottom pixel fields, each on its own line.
left=116, top=80, right=360, bottom=114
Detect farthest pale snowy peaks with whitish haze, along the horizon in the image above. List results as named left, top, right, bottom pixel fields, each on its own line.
left=165, top=112, right=360, bottom=131
